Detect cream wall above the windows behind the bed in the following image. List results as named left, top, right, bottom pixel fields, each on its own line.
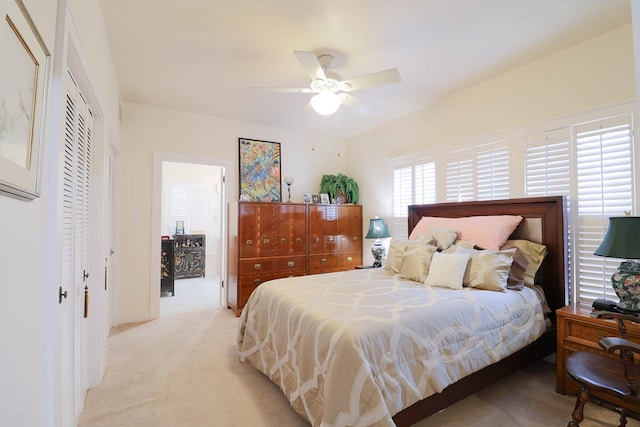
left=348, top=25, right=636, bottom=263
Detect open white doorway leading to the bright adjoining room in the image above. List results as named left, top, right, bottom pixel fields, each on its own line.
left=150, top=152, right=228, bottom=317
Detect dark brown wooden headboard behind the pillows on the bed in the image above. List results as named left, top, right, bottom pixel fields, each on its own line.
left=409, top=196, right=569, bottom=313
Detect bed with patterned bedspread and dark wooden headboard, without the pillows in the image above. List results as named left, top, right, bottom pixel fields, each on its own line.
left=238, top=196, right=568, bottom=426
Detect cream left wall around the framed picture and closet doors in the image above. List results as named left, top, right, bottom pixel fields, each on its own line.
left=0, top=0, right=119, bottom=426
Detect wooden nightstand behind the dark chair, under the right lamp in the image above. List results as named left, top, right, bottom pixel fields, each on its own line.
left=556, top=305, right=640, bottom=410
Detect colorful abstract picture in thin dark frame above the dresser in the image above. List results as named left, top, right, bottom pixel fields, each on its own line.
left=238, top=138, right=282, bottom=202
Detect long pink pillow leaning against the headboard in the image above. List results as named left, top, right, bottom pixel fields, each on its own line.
left=409, top=215, right=522, bottom=251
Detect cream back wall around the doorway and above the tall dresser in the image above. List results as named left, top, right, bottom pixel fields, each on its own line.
left=118, top=104, right=347, bottom=323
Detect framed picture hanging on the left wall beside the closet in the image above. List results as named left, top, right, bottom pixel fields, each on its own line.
left=0, top=0, right=51, bottom=200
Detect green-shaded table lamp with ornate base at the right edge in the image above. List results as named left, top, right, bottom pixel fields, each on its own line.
left=593, top=216, right=640, bottom=313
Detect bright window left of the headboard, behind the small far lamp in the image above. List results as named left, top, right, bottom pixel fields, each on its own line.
left=390, top=160, right=436, bottom=239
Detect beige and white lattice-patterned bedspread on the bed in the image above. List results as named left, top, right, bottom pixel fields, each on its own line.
left=238, top=269, right=545, bottom=426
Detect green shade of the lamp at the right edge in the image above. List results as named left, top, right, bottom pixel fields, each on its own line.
left=593, top=216, right=640, bottom=259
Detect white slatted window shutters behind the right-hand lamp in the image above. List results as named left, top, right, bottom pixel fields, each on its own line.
left=525, top=114, right=635, bottom=304
